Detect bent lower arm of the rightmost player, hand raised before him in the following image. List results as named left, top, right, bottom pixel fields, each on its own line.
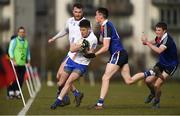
left=146, top=42, right=167, bottom=54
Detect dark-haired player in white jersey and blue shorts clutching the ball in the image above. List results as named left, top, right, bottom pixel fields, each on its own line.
left=51, top=19, right=97, bottom=109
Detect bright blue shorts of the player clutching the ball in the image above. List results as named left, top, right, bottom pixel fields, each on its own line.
left=64, top=58, right=88, bottom=75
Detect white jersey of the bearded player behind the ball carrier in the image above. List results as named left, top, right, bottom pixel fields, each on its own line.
left=66, top=17, right=85, bottom=55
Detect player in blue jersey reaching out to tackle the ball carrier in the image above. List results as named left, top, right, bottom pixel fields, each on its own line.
left=85, top=8, right=134, bottom=109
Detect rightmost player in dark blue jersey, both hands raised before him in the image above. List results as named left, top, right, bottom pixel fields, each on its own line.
left=139, top=22, right=179, bottom=108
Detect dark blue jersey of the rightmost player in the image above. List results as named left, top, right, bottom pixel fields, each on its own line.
left=155, top=33, right=179, bottom=66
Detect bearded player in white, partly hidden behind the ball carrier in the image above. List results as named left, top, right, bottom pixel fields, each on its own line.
left=48, top=3, right=85, bottom=105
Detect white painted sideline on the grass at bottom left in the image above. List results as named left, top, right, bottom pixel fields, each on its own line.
left=18, top=94, right=36, bottom=116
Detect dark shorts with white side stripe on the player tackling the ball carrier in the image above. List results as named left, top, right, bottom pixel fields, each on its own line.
left=108, top=50, right=128, bottom=68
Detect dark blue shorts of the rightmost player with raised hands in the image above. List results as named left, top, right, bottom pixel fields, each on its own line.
left=154, top=62, right=177, bottom=76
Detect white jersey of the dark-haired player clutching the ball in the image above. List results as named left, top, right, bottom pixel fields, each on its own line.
left=68, top=32, right=97, bottom=65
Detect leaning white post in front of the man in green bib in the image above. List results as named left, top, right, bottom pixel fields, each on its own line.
left=10, top=60, right=26, bottom=107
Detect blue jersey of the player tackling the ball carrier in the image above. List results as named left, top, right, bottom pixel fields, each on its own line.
left=100, top=20, right=124, bottom=55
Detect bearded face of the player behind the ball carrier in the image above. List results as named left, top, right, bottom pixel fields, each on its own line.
left=73, top=7, right=83, bottom=21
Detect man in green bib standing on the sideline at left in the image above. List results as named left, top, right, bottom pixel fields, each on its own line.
left=7, top=27, right=31, bottom=99
